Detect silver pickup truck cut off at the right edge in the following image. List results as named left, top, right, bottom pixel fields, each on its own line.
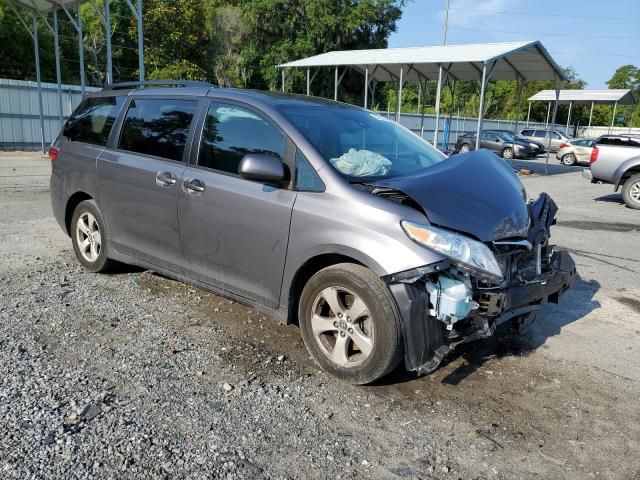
left=582, top=135, right=640, bottom=209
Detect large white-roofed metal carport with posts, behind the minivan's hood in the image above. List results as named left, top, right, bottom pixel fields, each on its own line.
left=277, top=41, right=565, bottom=172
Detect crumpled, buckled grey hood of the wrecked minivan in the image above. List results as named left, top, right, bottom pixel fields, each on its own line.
left=375, top=150, right=529, bottom=242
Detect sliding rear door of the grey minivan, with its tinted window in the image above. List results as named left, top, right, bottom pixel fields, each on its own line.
left=97, top=96, right=199, bottom=273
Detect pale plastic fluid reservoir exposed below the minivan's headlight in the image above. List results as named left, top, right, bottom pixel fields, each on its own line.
left=425, top=274, right=478, bottom=330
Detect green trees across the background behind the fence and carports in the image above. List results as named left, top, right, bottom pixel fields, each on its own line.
left=0, top=0, right=640, bottom=126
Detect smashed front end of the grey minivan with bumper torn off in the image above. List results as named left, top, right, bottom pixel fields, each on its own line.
left=385, top=194, right=576, bottom=374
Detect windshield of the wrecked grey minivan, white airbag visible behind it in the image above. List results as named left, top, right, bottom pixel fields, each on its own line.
left=279, top=105, right=445, bottom=182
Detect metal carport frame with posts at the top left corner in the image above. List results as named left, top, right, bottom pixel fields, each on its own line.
left=5, top=0, right=144, bottom=152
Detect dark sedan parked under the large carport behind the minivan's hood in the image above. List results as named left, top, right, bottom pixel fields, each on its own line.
left=455, top=130, right=545, bottom=158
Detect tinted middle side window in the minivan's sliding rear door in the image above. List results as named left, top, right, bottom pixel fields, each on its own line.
left=118, top=98, right=198, bottom=161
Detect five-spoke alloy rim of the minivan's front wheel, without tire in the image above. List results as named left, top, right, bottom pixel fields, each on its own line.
left=311, top=286, right=374, bottom=367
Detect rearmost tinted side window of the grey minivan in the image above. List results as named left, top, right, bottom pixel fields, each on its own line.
left=62, top=97, right=126, bottom=145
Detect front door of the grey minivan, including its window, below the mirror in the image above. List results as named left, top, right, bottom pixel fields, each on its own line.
left=178, top=102, right=296, bottom=307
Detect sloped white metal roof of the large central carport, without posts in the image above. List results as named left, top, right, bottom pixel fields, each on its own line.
left=278, top=41, right=565, bottom=81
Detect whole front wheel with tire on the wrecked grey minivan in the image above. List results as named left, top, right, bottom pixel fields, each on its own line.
left=298, top=263, right=402, bottom=385
